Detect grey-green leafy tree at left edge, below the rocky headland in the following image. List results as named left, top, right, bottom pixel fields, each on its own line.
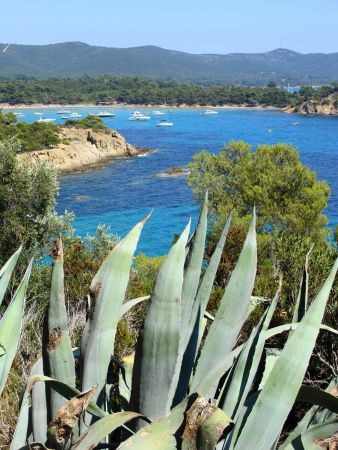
left=0, top=139, right=66, bottom=264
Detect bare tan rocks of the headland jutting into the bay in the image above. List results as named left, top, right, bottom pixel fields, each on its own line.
left=18, top=128, right=143, bottom=172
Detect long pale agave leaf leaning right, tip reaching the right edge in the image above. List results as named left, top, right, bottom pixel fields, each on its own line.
left=235, top=259, right=338, bottom=450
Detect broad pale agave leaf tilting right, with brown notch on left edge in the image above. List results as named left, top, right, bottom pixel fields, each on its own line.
left=82, top=216, right=149, bottom=406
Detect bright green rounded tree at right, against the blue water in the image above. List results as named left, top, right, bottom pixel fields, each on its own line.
left=187, top=142, right=330, bottom=240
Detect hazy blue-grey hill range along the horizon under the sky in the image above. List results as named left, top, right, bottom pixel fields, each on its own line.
left=0, top=42, right=338, bottom=85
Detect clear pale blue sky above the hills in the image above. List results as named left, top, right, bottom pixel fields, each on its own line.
left=0, top=0, right=338, bottom=54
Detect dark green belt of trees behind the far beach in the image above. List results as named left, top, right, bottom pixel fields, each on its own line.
left=0, top=76, right=338, bottom=107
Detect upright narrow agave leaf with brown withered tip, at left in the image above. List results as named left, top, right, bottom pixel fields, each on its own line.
left=44, top=239, right=76, bottom=417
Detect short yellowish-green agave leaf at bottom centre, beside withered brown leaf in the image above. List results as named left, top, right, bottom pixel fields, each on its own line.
left=118, top=399, right=188, bottom=450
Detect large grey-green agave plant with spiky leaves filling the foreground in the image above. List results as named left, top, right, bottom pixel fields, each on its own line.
left=0, top=193, right=338, bottom=450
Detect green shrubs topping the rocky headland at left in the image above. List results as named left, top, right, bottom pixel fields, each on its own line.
left=0, top=111, right=60, bottom=152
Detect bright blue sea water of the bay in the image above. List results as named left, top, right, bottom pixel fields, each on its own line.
left=10, top=107, right=338, bottom=255
